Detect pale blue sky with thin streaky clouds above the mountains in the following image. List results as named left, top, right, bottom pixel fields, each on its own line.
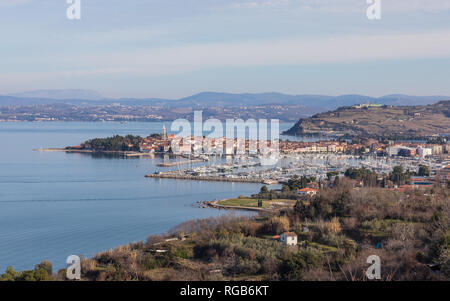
left=0, top=0, right=450, bottom=98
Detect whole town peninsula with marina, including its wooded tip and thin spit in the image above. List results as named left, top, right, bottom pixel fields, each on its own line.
left=31, top=121, right=450, bottom=189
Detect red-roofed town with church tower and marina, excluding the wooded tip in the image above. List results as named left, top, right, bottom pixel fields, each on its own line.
left=134, top=123, right=450, bottom=186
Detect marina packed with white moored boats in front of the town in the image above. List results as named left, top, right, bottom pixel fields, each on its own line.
left=146, top=154, right=448, bottom=185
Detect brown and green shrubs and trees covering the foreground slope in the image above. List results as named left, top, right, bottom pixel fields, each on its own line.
left=1, top=172, right=450, bottom=280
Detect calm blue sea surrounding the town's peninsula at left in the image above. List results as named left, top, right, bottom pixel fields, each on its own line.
left=0, top=122, right=291, bottom=273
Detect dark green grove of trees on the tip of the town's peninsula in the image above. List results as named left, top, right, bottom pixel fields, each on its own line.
left=74, top=135, right=142, bottom=152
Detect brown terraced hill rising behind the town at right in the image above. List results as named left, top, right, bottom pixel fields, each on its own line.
left=284, top=100, right=450, bottom=139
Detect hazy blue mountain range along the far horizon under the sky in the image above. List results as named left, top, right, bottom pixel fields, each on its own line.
left=0, top=90, right=450, bottom=111
